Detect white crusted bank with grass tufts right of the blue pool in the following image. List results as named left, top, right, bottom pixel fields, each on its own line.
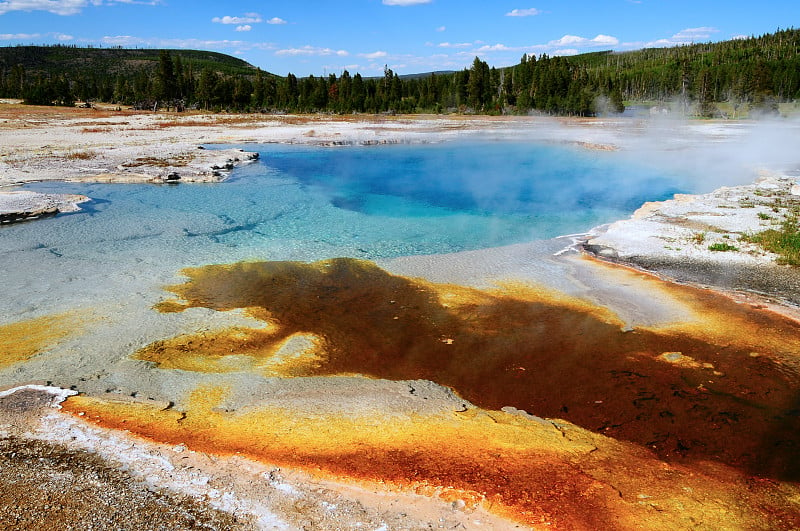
left=581, top=172, right=800, bottom=308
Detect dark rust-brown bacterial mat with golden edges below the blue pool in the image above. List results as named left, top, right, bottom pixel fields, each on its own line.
left=138, top=259, right=800, bottom=479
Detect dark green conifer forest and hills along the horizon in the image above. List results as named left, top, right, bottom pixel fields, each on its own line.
left=0, top=29, right=800, bottom=116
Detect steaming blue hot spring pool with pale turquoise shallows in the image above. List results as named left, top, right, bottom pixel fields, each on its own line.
left=14, top=141, right=695, bottom=263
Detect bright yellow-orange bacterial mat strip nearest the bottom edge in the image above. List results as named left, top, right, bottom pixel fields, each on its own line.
left=63, top=388, right=800, bottom=530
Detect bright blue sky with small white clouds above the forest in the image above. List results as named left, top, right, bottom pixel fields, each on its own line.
left=0, top=0, right=800, bottom=76
